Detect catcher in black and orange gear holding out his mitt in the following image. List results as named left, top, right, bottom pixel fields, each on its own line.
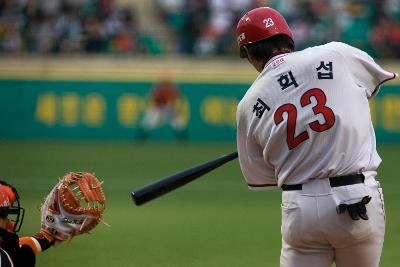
left=0, top=172, right=105, bottom=267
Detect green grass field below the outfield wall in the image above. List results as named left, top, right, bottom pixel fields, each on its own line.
left=0, top=141, right=400, bottom=267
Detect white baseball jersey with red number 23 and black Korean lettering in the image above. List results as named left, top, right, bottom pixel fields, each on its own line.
left=237, top=42, right=396, bottom=190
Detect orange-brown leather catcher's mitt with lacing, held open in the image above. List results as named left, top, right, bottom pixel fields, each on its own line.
left=40, top=172, right=106, bottom=241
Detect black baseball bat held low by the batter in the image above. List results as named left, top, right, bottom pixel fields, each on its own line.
left=132, top=151, right=238, bottom=206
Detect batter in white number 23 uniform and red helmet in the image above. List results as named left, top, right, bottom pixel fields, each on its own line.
left=236, top=7, right=396, bottom=267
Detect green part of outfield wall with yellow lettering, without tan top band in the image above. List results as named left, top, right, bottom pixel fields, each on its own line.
left=0, top=80, right=400, bottom=142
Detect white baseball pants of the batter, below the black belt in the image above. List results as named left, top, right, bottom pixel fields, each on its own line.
left=280, top=172, right=385, bottom=267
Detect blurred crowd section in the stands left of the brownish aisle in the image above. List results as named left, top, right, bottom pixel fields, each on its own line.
left=0, top=0, right=140, bottom=53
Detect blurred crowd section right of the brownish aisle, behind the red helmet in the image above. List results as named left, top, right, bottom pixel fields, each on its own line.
left=155, top=0, right=400, bottom=57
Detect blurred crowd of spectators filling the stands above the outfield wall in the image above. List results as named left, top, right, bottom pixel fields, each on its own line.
left=0, top=0, right=400, bottom=58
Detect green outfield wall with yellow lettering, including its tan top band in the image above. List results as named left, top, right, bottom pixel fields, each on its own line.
left=0, top=55, right=400, bottom=142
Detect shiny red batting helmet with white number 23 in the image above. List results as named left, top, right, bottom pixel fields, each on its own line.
left=236, top=7, right=293, bottom=47
